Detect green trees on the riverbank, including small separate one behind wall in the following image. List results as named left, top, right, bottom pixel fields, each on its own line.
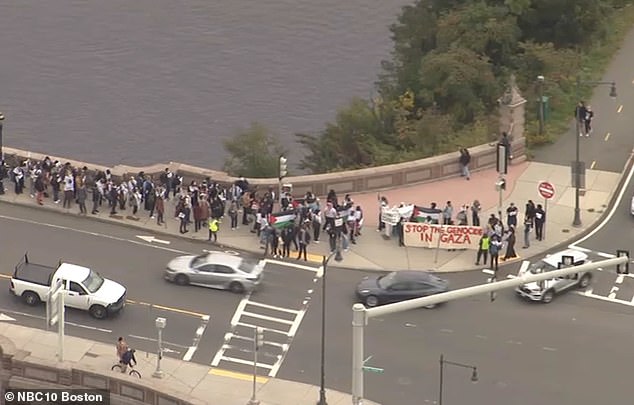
left=225, top=0, right=630, bottom=177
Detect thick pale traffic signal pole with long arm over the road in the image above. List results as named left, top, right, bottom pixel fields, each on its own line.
left=352, top=251, right=630, bottom=405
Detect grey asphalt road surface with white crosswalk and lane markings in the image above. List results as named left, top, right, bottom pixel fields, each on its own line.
left=0, top=205, right=634, bottom=405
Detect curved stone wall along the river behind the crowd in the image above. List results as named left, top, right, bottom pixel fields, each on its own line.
left=4, top=137, right=526, bottom=196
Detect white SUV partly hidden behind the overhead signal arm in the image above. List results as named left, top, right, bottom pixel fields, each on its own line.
left=515, top=249, right=592, bottom=304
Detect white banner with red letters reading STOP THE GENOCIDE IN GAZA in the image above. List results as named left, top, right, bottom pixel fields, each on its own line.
left=403, top=222, right=484, bottom=250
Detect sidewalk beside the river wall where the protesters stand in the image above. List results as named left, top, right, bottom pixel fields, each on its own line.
left=0, top=162, right=620, bottom=272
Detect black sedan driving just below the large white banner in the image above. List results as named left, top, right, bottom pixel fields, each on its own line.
left=356, top=270, right=449, bottom=307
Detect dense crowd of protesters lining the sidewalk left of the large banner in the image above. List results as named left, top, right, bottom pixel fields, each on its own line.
left=0, top=157, right=363, bottom=260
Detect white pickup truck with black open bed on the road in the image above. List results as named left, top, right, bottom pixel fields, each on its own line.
left=9, top=254, right=126, bottom=319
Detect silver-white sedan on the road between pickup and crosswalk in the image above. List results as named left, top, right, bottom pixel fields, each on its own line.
left=165, top=252, right=264, bottom=293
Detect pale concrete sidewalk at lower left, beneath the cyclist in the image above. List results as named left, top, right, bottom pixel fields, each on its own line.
left=0, top=320, right=375, bottom=405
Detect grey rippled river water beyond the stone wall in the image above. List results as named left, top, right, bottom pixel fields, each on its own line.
left=0, top=0, right=412, bottom=168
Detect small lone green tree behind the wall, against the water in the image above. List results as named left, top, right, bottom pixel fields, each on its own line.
left=224, top=122, right=286, bottom=178
